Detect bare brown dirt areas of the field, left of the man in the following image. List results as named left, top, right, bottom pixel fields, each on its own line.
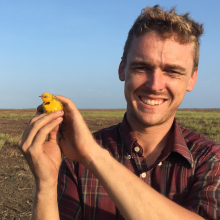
left=0, top=109, right=121, bottom=220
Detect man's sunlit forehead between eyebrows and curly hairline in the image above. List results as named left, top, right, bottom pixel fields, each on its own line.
left=127, top=32, right=194, bottom=66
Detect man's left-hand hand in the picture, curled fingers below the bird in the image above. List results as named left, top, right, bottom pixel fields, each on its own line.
left=18, top=111, right=64, bottom=189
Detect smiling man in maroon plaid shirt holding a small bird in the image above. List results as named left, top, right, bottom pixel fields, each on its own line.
left=19, top=6, right=220, bottom=220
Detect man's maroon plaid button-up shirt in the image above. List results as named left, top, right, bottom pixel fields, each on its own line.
left=58, top=117, right=220, bottom=220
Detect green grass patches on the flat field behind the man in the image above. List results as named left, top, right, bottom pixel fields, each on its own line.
left=0, top=109, right=220, bottom=145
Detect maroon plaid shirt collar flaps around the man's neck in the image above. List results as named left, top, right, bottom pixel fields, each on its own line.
left=121, top=113, right=193, bottom=167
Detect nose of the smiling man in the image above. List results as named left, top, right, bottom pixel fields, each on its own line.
left=145, top=70, right=165, bottom=92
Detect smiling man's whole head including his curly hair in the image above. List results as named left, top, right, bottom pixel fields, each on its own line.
left=119, top=6, right=203, bottom=129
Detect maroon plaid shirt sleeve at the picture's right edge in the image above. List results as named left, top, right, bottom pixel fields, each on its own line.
left=184, top=144, right=220, bottom=220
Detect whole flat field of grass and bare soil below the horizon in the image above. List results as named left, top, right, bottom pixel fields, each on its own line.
left=0, top=109, right=220, bottom=220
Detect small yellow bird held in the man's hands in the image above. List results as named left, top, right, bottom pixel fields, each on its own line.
left=39, top=92, right=63, bottom=114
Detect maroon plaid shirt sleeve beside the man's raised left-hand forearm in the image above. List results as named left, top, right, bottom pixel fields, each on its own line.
left=57, top=158, right=83, bottom=220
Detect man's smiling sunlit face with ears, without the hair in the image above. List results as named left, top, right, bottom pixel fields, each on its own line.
left=119, top=32, right=198, bottom=127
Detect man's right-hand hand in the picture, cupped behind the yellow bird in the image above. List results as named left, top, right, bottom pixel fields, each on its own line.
left=56, top=95, right=102, bottom=165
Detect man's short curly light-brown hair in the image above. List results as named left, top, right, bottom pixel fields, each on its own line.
left=122, top=5, right=203, bottom=72
